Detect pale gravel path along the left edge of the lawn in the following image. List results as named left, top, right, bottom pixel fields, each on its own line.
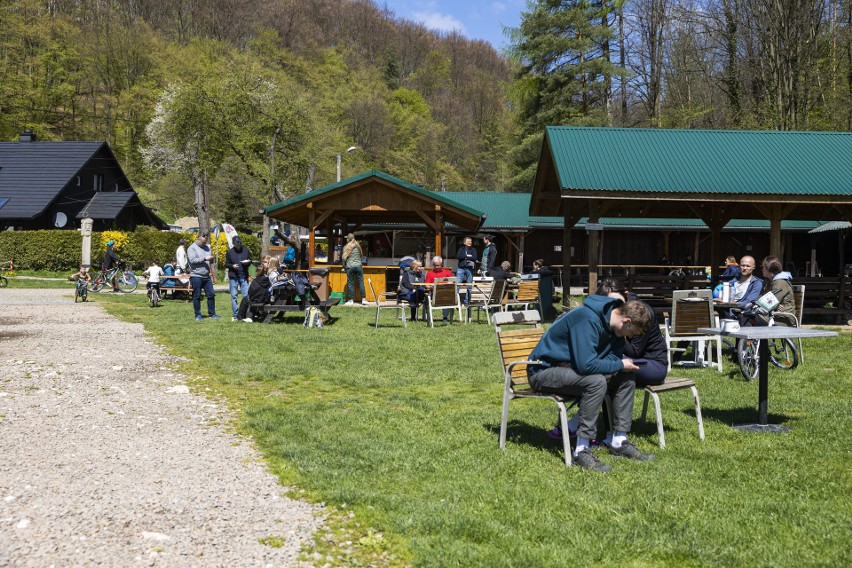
left=0, top=288, right=322, bottom=567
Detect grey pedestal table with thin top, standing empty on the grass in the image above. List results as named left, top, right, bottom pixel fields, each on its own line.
left=698, top=325, right=837, bottom=432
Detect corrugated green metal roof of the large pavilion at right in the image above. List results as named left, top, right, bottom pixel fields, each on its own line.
left=545, top=126, right=852, bottom=196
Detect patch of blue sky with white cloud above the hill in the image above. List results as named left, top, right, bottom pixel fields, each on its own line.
left=376, top=0, right=527, bottom=50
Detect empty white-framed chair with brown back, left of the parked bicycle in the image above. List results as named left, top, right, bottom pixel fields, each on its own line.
left=664, top=290, right=722, bottom=373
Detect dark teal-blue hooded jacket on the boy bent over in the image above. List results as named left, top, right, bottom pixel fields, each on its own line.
left=527, top=296, right=624, bottom=376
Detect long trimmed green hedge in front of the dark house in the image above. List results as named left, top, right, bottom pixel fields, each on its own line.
left=0, top=227, right=260, bottom=272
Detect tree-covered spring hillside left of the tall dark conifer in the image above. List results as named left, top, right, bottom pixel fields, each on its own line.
left=0, top=0, right=512, bottom=224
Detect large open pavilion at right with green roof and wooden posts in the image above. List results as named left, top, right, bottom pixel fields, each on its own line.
left=530, top=126, right=852, bottom=297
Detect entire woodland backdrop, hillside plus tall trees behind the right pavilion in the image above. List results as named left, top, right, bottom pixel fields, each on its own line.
left=0, top=0, right=852, bottom=225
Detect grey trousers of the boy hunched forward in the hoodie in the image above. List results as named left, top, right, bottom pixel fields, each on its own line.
left=529, top=367, right=636, bottom=440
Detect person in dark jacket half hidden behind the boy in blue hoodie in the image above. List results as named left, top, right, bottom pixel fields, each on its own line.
left=547, top=278, right=669, bottom=440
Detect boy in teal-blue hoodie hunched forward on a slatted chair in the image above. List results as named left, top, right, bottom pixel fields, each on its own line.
left=527, top=295, right=654, bottom=472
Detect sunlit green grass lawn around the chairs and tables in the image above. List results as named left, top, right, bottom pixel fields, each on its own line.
left=90, top=294, right=852, bottom=567
